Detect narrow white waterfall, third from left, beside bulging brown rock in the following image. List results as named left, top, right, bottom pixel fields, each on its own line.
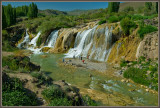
left=45, top=30, right=58, bottom=47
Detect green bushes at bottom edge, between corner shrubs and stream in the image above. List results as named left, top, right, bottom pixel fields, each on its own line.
left=42, top=85, right=97, bottom=106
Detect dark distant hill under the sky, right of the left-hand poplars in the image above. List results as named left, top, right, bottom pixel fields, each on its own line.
left=38, top=9, right=67, bottom=15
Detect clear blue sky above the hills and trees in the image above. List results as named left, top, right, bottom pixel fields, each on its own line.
left=2, top=2, right=111, bottom=11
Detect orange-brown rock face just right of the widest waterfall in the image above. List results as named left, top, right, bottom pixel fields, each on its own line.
left=107, top=29, right=140, bottom=63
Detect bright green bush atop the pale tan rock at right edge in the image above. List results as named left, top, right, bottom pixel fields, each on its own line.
left=138, top=25, right=158, bottom=39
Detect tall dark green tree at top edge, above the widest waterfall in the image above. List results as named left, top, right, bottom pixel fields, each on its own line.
left=108, top=2, right=120, bottom=13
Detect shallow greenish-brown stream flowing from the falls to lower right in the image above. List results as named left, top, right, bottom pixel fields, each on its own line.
left=30, top=53, right=158, bottom=106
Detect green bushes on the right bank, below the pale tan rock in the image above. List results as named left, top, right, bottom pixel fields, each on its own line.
left=123, top=57, right=158, bottom=91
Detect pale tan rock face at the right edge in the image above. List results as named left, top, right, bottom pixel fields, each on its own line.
left=136, top=32, right=158, bottom=59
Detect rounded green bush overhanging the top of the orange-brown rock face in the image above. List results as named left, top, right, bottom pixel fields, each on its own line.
left=120, top=17, right=136, bottom=36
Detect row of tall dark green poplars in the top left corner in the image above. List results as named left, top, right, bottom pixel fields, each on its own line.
left=2, top=3, right=38, bottom=29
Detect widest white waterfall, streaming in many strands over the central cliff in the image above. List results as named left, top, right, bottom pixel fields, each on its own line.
left=66, top=26, right=113, bottom=61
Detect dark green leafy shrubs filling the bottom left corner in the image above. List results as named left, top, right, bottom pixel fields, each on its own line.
left=2, top=73, right=38, bottom=106
